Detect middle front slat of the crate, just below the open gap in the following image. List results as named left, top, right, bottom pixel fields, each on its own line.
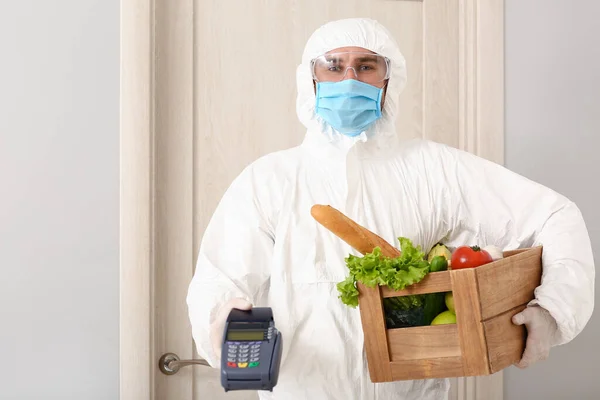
left=387, top=324, right=461, bottom=362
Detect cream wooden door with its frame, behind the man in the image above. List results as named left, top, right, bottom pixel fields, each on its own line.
left=121, top=0, right=504, bottom=400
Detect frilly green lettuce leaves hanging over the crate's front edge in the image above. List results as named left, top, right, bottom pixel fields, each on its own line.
left=337, top=237, right=429, bottom=308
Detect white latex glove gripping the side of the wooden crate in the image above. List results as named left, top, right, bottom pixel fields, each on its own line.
left=512, top=305, right=558, bottom=369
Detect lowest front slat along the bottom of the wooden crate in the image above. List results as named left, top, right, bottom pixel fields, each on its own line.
left=390, top=357, right=464, bottom=380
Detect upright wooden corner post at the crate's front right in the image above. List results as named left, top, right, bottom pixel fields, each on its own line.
left=450, top=269, right=489, bottom=376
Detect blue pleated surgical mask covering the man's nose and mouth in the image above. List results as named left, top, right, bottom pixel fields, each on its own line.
left=316, top=79, right=383, bottom=137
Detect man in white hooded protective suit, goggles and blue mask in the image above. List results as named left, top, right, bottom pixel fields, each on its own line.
left=188, top=19, right=595, bottom=400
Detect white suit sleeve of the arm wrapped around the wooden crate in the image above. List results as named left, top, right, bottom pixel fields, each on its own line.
left=440, top=147, right=595, bottom=345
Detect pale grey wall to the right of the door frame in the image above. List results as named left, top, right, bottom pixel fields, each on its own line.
left=505, top=0, right=600, bottom=400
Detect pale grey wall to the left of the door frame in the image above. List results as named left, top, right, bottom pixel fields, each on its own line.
left=0, top=0, right=119, bottom=400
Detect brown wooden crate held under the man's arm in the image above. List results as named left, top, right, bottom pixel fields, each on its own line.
left=358, top=247, right=542, bottom=382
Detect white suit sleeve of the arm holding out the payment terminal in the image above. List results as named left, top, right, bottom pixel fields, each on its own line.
left=187, top=167, right=274, bottom=367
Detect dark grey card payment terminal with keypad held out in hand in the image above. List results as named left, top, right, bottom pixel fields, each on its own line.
left=221, top=307, right=282, bottom=392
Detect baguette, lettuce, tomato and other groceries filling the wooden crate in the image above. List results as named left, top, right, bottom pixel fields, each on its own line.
left=311, top=204, right=510, bottom=329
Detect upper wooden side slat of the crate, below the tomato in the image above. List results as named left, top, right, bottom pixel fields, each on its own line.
left=475, top=247, right=542, bottom=320
